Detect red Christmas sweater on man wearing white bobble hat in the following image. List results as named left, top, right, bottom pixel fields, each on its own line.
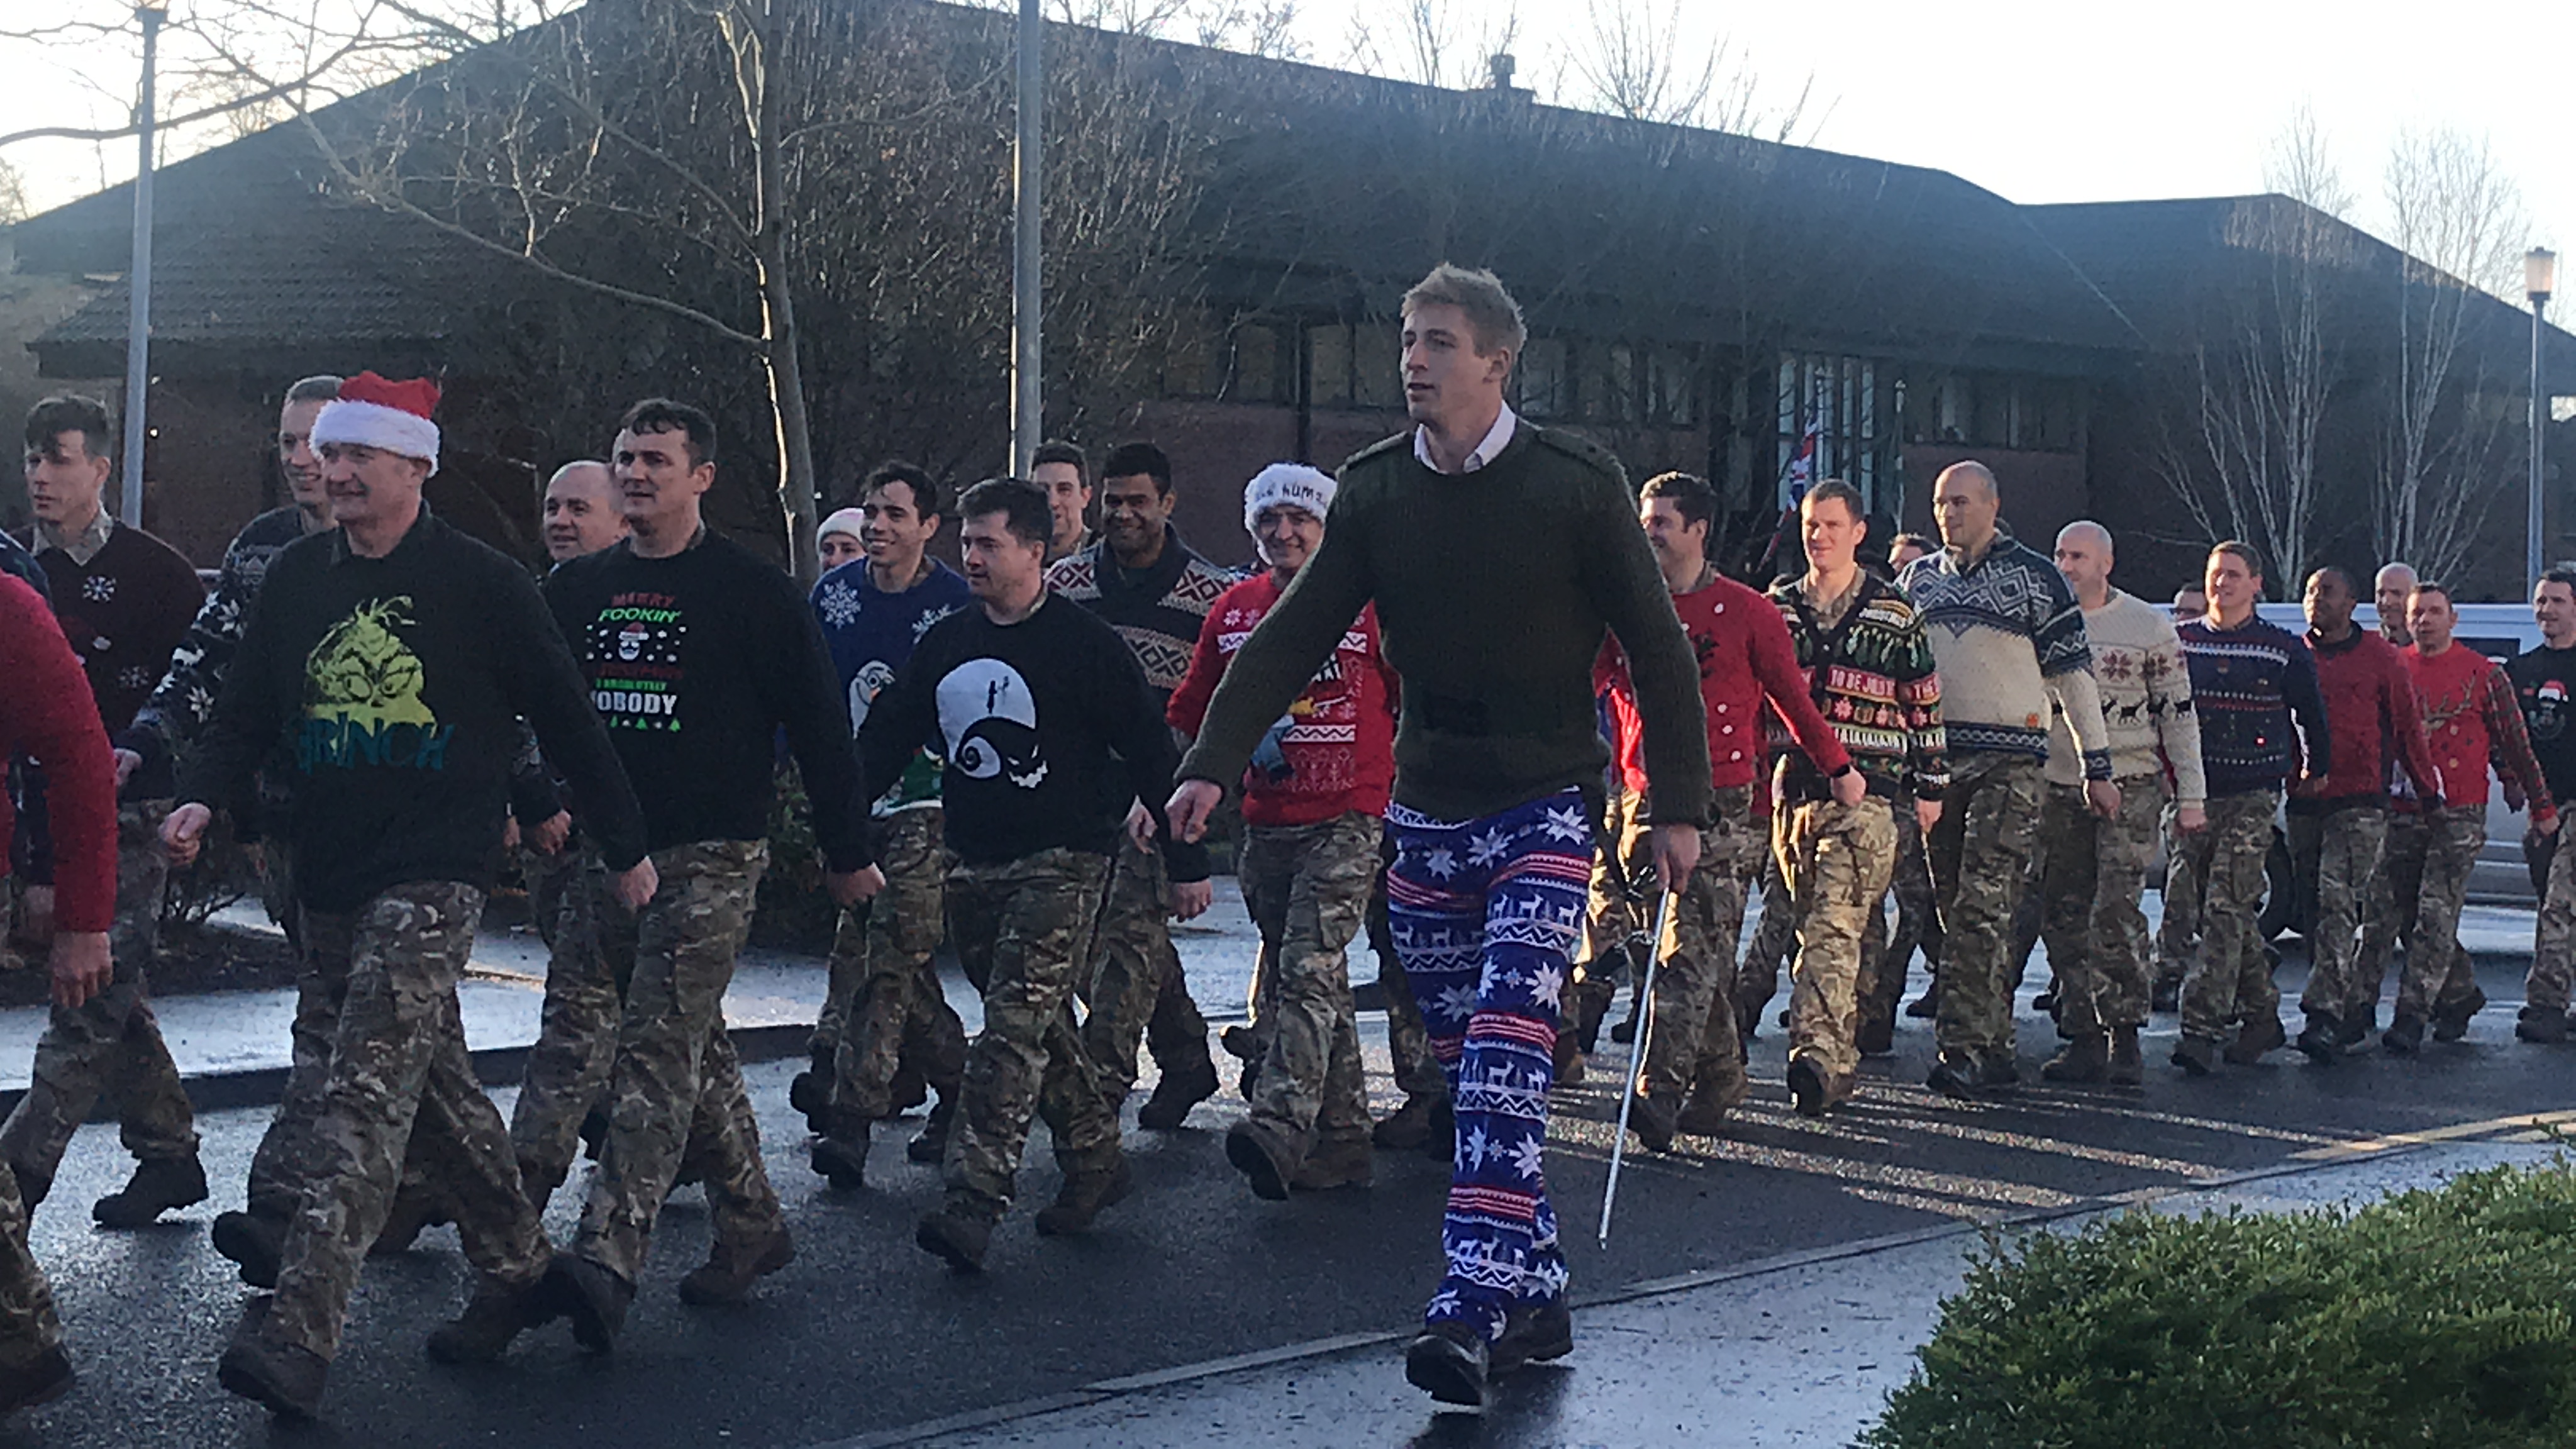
left=1164, top=570, right=1401, bottom=825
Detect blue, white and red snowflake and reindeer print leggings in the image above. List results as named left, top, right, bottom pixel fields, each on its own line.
left=1386, top=789, right=1592, bottom=1343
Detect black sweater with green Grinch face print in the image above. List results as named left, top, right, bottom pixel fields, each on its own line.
left=178, top=508, right=644, bottom=913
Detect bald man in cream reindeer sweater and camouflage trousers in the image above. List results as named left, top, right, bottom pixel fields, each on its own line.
left=2040, top=521, right=2207, bottom=1085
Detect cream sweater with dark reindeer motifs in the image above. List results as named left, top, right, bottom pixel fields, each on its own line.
left=2048, top=588, right=2207, bottom=804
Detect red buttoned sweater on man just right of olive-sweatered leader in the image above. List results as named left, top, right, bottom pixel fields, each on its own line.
left=1592, top=575, right=1852, bottom=792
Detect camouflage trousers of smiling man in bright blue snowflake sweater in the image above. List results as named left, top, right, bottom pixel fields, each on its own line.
left=811, top=807, right=966, bottom=1121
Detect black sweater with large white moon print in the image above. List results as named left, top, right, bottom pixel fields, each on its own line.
left=858, top=598, right=1208, bottom=882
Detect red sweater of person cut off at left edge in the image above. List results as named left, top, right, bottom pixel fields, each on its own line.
left=0, top=575, right=116, bottom=933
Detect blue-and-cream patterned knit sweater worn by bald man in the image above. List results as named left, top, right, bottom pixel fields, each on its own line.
left=1896, top=526, right=2110, bottom=779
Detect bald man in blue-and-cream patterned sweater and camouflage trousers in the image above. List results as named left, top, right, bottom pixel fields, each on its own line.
left=1899, top=462, right=2120, bottom=1098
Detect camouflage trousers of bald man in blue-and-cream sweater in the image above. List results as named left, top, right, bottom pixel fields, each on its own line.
left=1924, top=753, right=2048, bottom=1060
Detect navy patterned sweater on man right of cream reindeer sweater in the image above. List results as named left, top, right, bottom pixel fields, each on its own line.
left=2174, top=614, right=2334, bottom=799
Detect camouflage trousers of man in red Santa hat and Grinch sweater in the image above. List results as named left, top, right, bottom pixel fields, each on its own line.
left=265, top=882, right=552, bottom=1359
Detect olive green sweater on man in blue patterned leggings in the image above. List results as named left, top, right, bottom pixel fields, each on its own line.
left=1180, top=423, right=1708, bottom=823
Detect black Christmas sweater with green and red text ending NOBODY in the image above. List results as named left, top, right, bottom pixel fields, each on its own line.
left=546, top=531, right=868, bottom=872
